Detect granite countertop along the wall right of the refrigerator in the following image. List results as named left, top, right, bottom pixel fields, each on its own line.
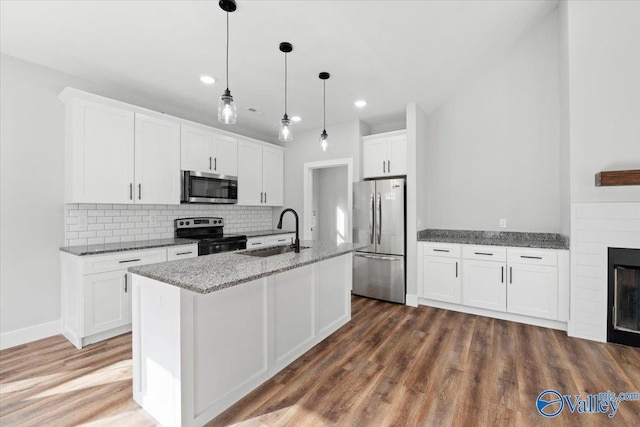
left=418, top=229, right=569, bottom=249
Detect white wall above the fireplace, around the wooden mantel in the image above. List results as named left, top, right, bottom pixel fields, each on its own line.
left=568, top=1, right=640, bottom=202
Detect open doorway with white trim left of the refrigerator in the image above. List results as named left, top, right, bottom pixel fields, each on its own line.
left=303, top=159, right=353, bottom=244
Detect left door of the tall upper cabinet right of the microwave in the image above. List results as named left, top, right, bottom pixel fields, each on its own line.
left=238, top=141, right=264, bottom=206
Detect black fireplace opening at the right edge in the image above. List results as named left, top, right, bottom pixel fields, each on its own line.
left=607, top=248, right=640, bottom=347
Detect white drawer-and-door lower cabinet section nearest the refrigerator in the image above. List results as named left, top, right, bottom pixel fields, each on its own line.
left=418, top=243, right=462, bottom=304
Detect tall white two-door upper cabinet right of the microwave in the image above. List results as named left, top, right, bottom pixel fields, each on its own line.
left=238, top=140, right=284, bottom=206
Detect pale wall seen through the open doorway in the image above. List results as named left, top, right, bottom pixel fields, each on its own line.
left=313, top=166, right=350, bottom=247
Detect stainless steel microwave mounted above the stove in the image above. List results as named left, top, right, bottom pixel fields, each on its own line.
left=180, top=171, right=238, bottom=204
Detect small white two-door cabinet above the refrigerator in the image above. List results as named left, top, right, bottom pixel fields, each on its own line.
left=362, top=130, right=407, bottom=178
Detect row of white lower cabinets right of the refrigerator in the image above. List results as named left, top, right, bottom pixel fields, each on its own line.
left=418, top=242, right=569, bottom=321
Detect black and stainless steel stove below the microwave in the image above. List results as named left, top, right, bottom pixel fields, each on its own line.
left=175, top=218, right=247, bottom=256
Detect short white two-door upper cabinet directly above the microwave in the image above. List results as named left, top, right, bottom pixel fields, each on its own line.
left=180, top=125, right=238, bottom=176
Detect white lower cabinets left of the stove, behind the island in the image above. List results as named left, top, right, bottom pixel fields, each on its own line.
left=60, top=244, right=198, bottom=348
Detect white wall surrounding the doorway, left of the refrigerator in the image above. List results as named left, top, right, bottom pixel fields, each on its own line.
left=273, top=121, right=368, bottom=236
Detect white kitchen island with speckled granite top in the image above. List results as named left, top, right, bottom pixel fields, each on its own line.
left=129, top=241, right=359, bottom=426
